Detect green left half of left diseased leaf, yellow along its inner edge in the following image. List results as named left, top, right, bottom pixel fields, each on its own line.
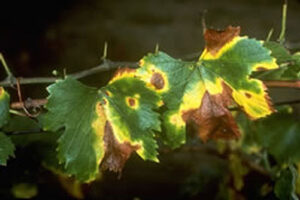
left=42, top=78, right=104, bottom=181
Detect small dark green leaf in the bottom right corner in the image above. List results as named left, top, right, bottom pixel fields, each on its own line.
left=274, top=166, right=298, bottom=200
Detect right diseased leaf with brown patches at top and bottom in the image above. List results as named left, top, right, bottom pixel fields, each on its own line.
left=137, top=26, right=278, bottom=147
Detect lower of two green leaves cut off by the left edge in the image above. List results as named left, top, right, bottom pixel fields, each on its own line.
left=0, top=132, right=15, bottom=165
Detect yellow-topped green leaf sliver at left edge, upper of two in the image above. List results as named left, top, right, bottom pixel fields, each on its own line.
left=0, top=87, right=10, bottom=128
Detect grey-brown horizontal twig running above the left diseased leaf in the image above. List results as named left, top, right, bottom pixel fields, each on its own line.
left=0, top=60, right=138, bottom=87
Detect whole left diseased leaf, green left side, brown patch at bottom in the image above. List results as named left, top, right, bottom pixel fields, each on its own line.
left=42, top=75, right=161, bottom=181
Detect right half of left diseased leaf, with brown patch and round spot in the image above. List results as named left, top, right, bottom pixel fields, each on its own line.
left=101, top=69, right=161, bottom=172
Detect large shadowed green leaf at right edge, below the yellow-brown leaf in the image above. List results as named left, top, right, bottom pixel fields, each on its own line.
left=239, top=106, right=300, bottom=163
